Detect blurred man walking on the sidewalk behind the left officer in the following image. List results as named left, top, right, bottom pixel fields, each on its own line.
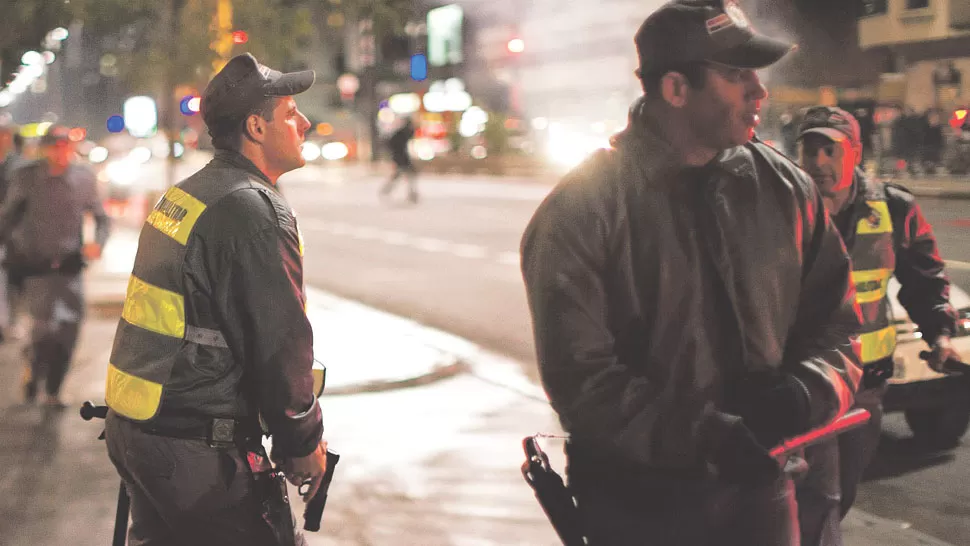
left=0, top=125, right=110, bottom=409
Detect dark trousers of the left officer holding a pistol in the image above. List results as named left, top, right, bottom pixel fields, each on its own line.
left=105, top=412, right=305, bottom=546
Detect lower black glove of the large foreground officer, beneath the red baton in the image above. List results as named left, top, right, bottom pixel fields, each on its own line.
left=709, top=410, right=781, bottom=485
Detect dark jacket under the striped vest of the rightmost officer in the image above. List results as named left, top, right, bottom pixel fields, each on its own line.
left=835, top=169, right=957, bottom=345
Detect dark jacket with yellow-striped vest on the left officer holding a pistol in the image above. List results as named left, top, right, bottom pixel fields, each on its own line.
left=106, top=151, right=323, bottom=457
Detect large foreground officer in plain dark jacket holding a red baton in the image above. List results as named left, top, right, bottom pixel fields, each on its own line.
left=522, top=0, right=859, bottom=546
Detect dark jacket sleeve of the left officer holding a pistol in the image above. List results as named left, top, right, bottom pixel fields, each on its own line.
left=210, top=190, right=323, bottom=457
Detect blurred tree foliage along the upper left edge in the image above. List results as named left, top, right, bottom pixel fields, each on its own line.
left=0, top=0, right=414, bottom=92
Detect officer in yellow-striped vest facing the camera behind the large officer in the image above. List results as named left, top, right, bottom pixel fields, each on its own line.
left=798, top=106, right=959, bottom=530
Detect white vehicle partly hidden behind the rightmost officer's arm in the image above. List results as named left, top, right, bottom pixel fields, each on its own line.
left=883, top=278, right=970, bottom=448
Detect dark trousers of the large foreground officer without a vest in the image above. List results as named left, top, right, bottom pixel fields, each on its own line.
left=569, top=454, right=798, bottom=546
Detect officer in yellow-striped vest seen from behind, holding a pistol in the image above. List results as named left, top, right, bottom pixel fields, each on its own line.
left=105, top=54, right=326, bottom=546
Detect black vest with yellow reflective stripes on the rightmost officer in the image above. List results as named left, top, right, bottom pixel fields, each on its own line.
left=851, top=193, right=896, bottom=364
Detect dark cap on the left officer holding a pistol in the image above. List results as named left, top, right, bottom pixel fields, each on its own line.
left=199, top=53, right=316, bottom=130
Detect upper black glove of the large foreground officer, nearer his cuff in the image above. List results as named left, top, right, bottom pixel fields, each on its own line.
left=726, top=373, right=811, bottom=449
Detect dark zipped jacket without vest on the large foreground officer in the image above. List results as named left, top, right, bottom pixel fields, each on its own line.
left=522, top=105, right=859, bottom=468
